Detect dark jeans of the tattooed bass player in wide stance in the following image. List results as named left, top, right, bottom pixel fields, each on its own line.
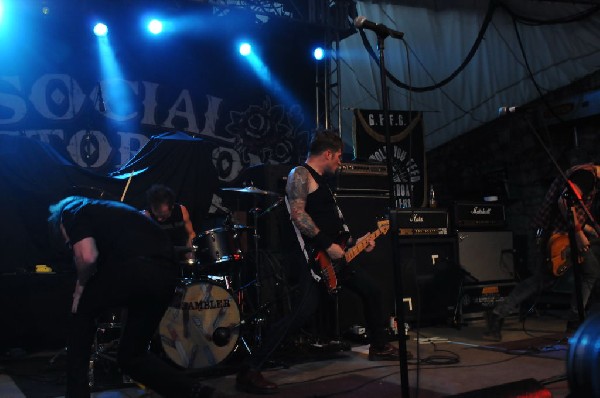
left=248, top=261, right=387, bottom=370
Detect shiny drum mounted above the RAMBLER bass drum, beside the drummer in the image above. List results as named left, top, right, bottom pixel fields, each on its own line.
left=192, top=228, right=243, bottom=265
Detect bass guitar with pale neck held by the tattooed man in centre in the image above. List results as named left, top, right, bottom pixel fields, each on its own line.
left=313, top=220, right=390, bottom=294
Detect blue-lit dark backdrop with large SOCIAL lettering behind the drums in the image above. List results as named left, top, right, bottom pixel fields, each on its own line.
left=0, top=2, right=319, bottom=272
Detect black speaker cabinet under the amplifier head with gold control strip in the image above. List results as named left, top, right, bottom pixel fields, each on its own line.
left=399, top=237, right=461, bottom=325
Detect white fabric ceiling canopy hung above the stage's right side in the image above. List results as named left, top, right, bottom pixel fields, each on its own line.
left=332, top=0, right=600, bottom=150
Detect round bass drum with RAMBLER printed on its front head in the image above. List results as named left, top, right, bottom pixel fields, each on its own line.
left=159, top=281, right=240, bottom=369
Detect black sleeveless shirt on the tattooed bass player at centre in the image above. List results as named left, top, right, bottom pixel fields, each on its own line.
left=302, top=163, right=348, bottom=243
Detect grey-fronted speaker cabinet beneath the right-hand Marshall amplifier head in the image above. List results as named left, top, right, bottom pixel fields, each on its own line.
left=458, top=231, right=515, bottom=283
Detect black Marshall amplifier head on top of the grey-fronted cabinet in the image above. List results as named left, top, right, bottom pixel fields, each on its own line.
left=454, top=202, right=506, bottom=230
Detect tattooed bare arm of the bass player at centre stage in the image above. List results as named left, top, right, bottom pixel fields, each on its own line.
left=285, top=167, right=344, bottom=259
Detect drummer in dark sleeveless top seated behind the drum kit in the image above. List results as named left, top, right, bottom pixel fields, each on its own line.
left=143, top=184, right=196, bottom=260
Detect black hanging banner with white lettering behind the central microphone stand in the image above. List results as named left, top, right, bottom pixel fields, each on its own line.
left=352, top=109, right=427, bottom=208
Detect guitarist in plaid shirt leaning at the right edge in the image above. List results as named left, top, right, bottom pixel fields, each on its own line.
left=483, top=164, right=600, bottom=341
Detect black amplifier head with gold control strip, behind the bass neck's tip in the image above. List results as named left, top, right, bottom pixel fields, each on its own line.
left=390, top=208, right=448, bottom=236
